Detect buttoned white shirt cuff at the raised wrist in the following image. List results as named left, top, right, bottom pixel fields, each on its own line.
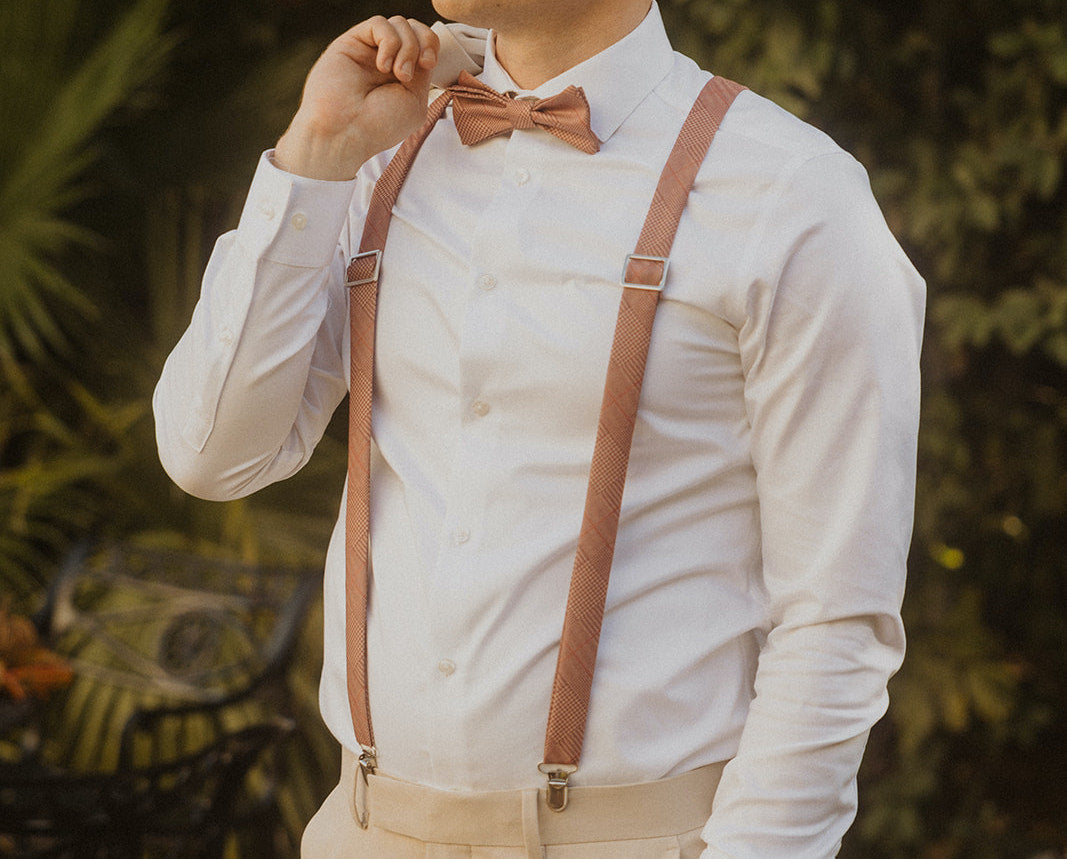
left=237, top=150, right=356, bottom=268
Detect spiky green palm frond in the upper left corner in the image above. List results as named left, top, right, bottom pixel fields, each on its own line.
left=0, top=0, right=174, bottom=366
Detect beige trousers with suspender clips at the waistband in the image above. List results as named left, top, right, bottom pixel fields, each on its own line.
left=300, top=751, right=723, bottom=859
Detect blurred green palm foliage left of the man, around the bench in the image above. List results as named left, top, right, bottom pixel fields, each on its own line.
left=0, top=0, right=344, bottom=856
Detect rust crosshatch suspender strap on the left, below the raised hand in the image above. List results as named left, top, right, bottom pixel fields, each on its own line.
left=345, top=93, right=451, bottom=749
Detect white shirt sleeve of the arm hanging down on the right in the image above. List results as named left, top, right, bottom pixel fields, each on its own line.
left=703, top=152, right=925, bottom=859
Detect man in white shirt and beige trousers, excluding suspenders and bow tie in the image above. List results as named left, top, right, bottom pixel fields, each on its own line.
left=156, top=0, right=923, bottom=859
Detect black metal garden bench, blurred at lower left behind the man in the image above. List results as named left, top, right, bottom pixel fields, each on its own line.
left=0, top=546, right=321, bottom=857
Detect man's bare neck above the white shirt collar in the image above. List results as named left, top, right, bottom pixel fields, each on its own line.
left=496, top=0, right=651, bottom=90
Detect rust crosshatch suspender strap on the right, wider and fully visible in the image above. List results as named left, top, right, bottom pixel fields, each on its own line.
left=542, top=77, right=745, bottom=772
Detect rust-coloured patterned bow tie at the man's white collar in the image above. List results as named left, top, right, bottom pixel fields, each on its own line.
left=449, top=71, right=600, bottom=155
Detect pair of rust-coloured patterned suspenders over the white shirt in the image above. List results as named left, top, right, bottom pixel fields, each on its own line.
left=346, top=77, right=745, bottom=827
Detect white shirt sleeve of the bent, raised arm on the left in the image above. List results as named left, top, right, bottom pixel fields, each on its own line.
left=153, top=154, right=355, bottom=500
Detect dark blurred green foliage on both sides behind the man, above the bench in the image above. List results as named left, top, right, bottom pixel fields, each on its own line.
left=0, top=0, right=1067, bottom=859
